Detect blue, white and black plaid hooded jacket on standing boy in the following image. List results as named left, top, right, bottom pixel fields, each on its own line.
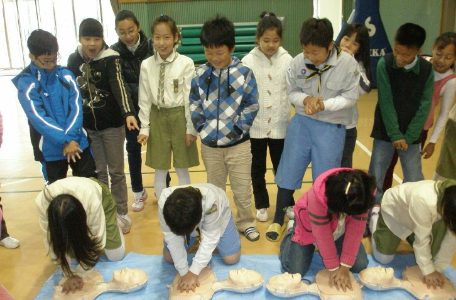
left=190, top=57, right=259, bottom=147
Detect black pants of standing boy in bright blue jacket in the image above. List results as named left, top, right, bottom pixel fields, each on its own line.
left=46, top=147, right=97, bottom=184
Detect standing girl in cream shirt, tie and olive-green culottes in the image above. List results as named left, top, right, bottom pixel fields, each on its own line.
left=138, top=15, right=199, bottom=199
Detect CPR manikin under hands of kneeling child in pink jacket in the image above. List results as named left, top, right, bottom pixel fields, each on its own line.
left=266, top=270, right=363, bottom=300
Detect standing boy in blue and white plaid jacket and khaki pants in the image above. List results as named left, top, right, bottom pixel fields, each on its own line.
left=190, top=16, right=260, bottom=241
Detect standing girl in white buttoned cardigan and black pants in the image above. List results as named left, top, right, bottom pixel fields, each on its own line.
left=242, top=12, right=293, bottom=222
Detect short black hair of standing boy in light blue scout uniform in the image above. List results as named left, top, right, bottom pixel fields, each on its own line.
left=299, top=18, right=334, bottom=49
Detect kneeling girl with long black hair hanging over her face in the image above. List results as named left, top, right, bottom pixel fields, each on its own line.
left=35, top=177, right=125, bottom=294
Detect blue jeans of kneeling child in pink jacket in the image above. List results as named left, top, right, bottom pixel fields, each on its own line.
left=279, top=223, right=369, bottom=277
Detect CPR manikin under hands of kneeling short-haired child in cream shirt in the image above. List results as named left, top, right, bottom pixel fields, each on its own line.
left=168, top=267, right=264, bottom=300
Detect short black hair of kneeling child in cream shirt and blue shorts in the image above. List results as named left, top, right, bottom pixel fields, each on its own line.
left=163, top=186, right=203, bottom=236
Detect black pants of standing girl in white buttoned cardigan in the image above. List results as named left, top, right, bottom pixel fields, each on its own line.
left=250, top=138, right=285, bottom=209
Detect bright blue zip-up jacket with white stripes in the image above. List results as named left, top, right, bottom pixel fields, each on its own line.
left=12, top=62, right=89, bottom=161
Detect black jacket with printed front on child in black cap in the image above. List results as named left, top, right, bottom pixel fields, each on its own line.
left=68, top=45, right=136, bottom=130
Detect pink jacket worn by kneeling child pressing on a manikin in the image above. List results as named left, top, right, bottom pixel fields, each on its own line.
left=292, top=168, right=367, bottom=269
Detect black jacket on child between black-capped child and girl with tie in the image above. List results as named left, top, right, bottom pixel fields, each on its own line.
left=111, top=30, right=154, bottom=113
